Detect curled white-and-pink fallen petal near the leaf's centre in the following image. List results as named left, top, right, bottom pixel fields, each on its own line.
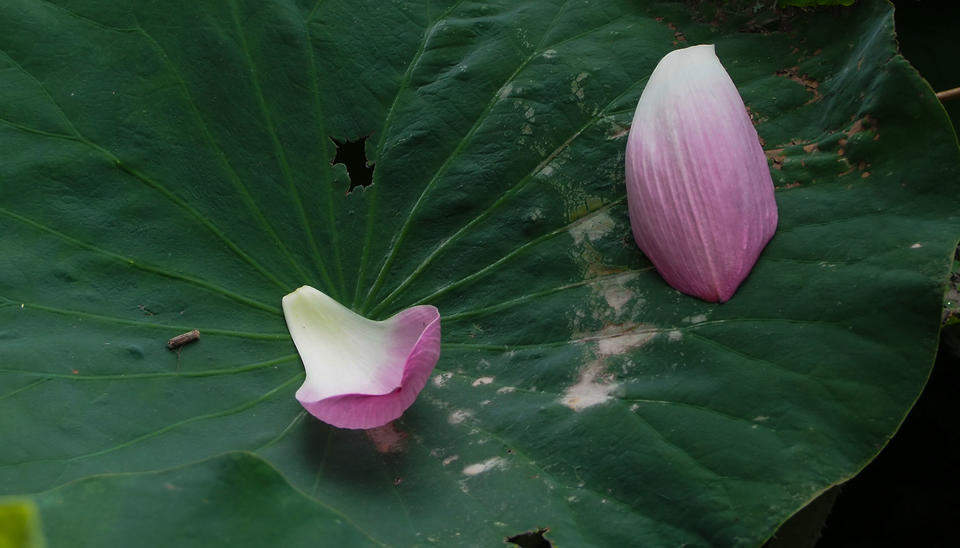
left=283, top=286, right=440, bottom=428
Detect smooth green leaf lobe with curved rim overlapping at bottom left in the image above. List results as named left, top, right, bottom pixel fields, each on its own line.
left=31, top=452, right=376, bottom=546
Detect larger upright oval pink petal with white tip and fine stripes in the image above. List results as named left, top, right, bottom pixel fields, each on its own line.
left=626, top=45, right=777, bottom=302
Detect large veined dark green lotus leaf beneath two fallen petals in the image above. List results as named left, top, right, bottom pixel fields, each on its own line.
left=0, top=0, right=960, bottom=546
